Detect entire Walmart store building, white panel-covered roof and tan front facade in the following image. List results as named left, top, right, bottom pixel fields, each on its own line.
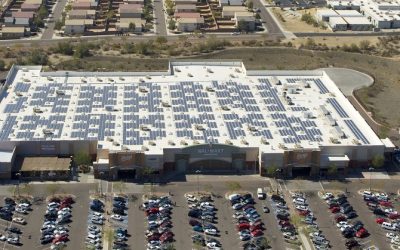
left=0, top=61, right=385, bottom=179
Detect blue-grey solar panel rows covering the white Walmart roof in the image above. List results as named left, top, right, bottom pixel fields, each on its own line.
left=0, top=70, right=369, bottom=145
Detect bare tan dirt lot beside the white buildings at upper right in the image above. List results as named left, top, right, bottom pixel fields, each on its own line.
left=273, top=8, right=332, bottom=33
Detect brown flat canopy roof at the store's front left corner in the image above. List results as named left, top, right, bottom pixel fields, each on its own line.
left=17, top=157, right=71, bottom=172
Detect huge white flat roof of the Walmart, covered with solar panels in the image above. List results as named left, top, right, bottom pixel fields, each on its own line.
left=0, top=62, right=383, bottom=153
